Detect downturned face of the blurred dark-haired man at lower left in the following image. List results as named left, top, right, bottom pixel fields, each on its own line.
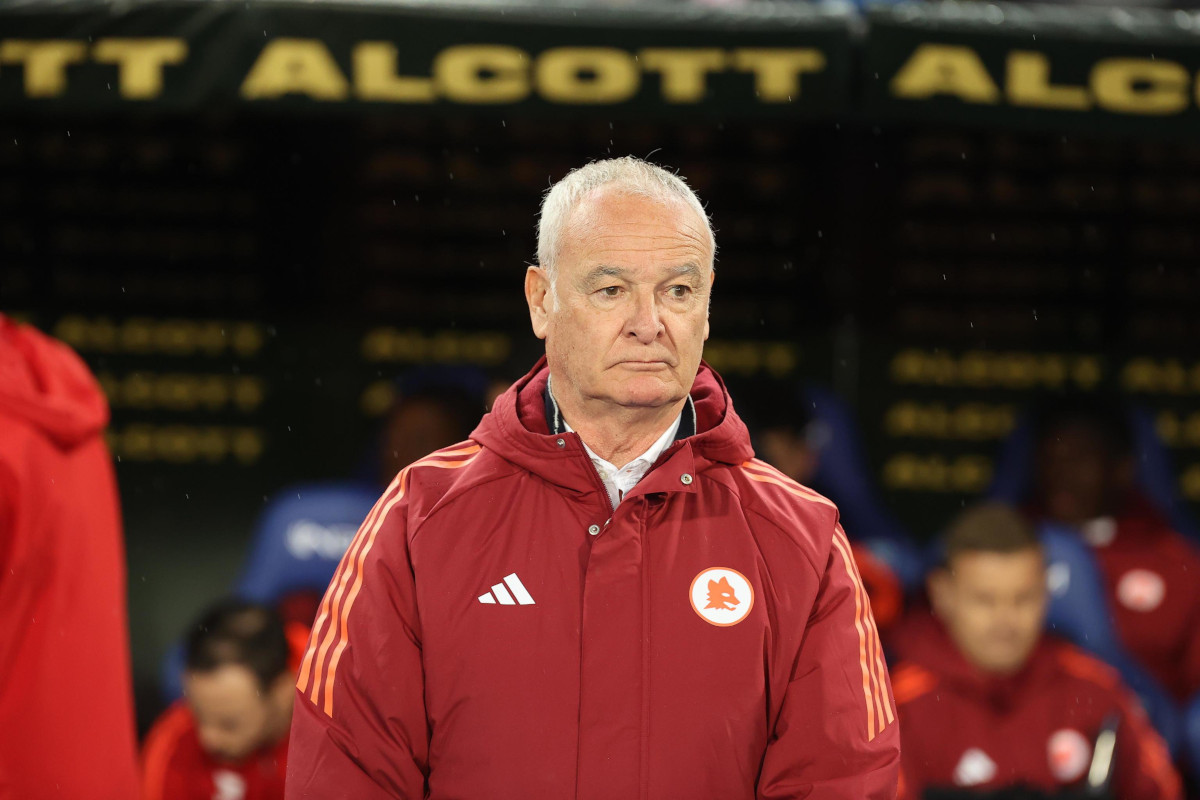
left=184, top=664, right=290, bottom=762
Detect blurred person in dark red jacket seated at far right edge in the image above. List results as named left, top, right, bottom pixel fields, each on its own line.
left=1031, top=399, right=1200, bottom=700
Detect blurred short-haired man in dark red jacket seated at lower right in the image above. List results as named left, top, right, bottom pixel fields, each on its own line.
left=893, top=505, right=1181, bottom=800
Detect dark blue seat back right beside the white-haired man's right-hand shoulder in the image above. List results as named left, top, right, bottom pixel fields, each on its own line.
left=802, top=384, right=925, bottom=590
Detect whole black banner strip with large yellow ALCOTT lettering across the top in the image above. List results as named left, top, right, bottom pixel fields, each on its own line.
left=7, top=0, right=1200, bottom=126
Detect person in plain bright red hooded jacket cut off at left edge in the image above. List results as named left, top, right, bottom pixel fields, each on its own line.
left=0, top=314, right=137, bottom=800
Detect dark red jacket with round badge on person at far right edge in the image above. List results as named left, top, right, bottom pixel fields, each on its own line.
left=1084, top=497, right=1200, bottom=700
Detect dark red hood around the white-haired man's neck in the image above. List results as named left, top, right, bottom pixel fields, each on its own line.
left=470, top=356, right=754, bottom=491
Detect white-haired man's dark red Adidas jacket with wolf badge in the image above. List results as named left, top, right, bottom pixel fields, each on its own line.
left=287, top=362, right=899, bottom=800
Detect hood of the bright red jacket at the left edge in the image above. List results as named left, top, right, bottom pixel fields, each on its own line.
left=0, top=314, right=108, bottom=447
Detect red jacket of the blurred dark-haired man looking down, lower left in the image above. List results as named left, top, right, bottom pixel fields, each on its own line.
left=142, top=700, right=288, bottom=800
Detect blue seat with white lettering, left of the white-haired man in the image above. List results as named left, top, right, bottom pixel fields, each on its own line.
left=160, top=482, right=379, bottom=703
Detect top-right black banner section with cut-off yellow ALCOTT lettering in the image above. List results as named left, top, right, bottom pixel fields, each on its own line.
left=864, top=4, right=1200, bottom=132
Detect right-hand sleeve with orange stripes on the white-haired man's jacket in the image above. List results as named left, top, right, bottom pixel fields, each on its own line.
left=758, top=525, right=900, bottom=800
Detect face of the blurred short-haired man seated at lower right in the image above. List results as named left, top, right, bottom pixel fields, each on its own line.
left=929, top=547, right=1046, bottom=675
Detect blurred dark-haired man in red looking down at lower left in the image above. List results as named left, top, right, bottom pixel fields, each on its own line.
left=142, top=601, right=295, bottom=800
